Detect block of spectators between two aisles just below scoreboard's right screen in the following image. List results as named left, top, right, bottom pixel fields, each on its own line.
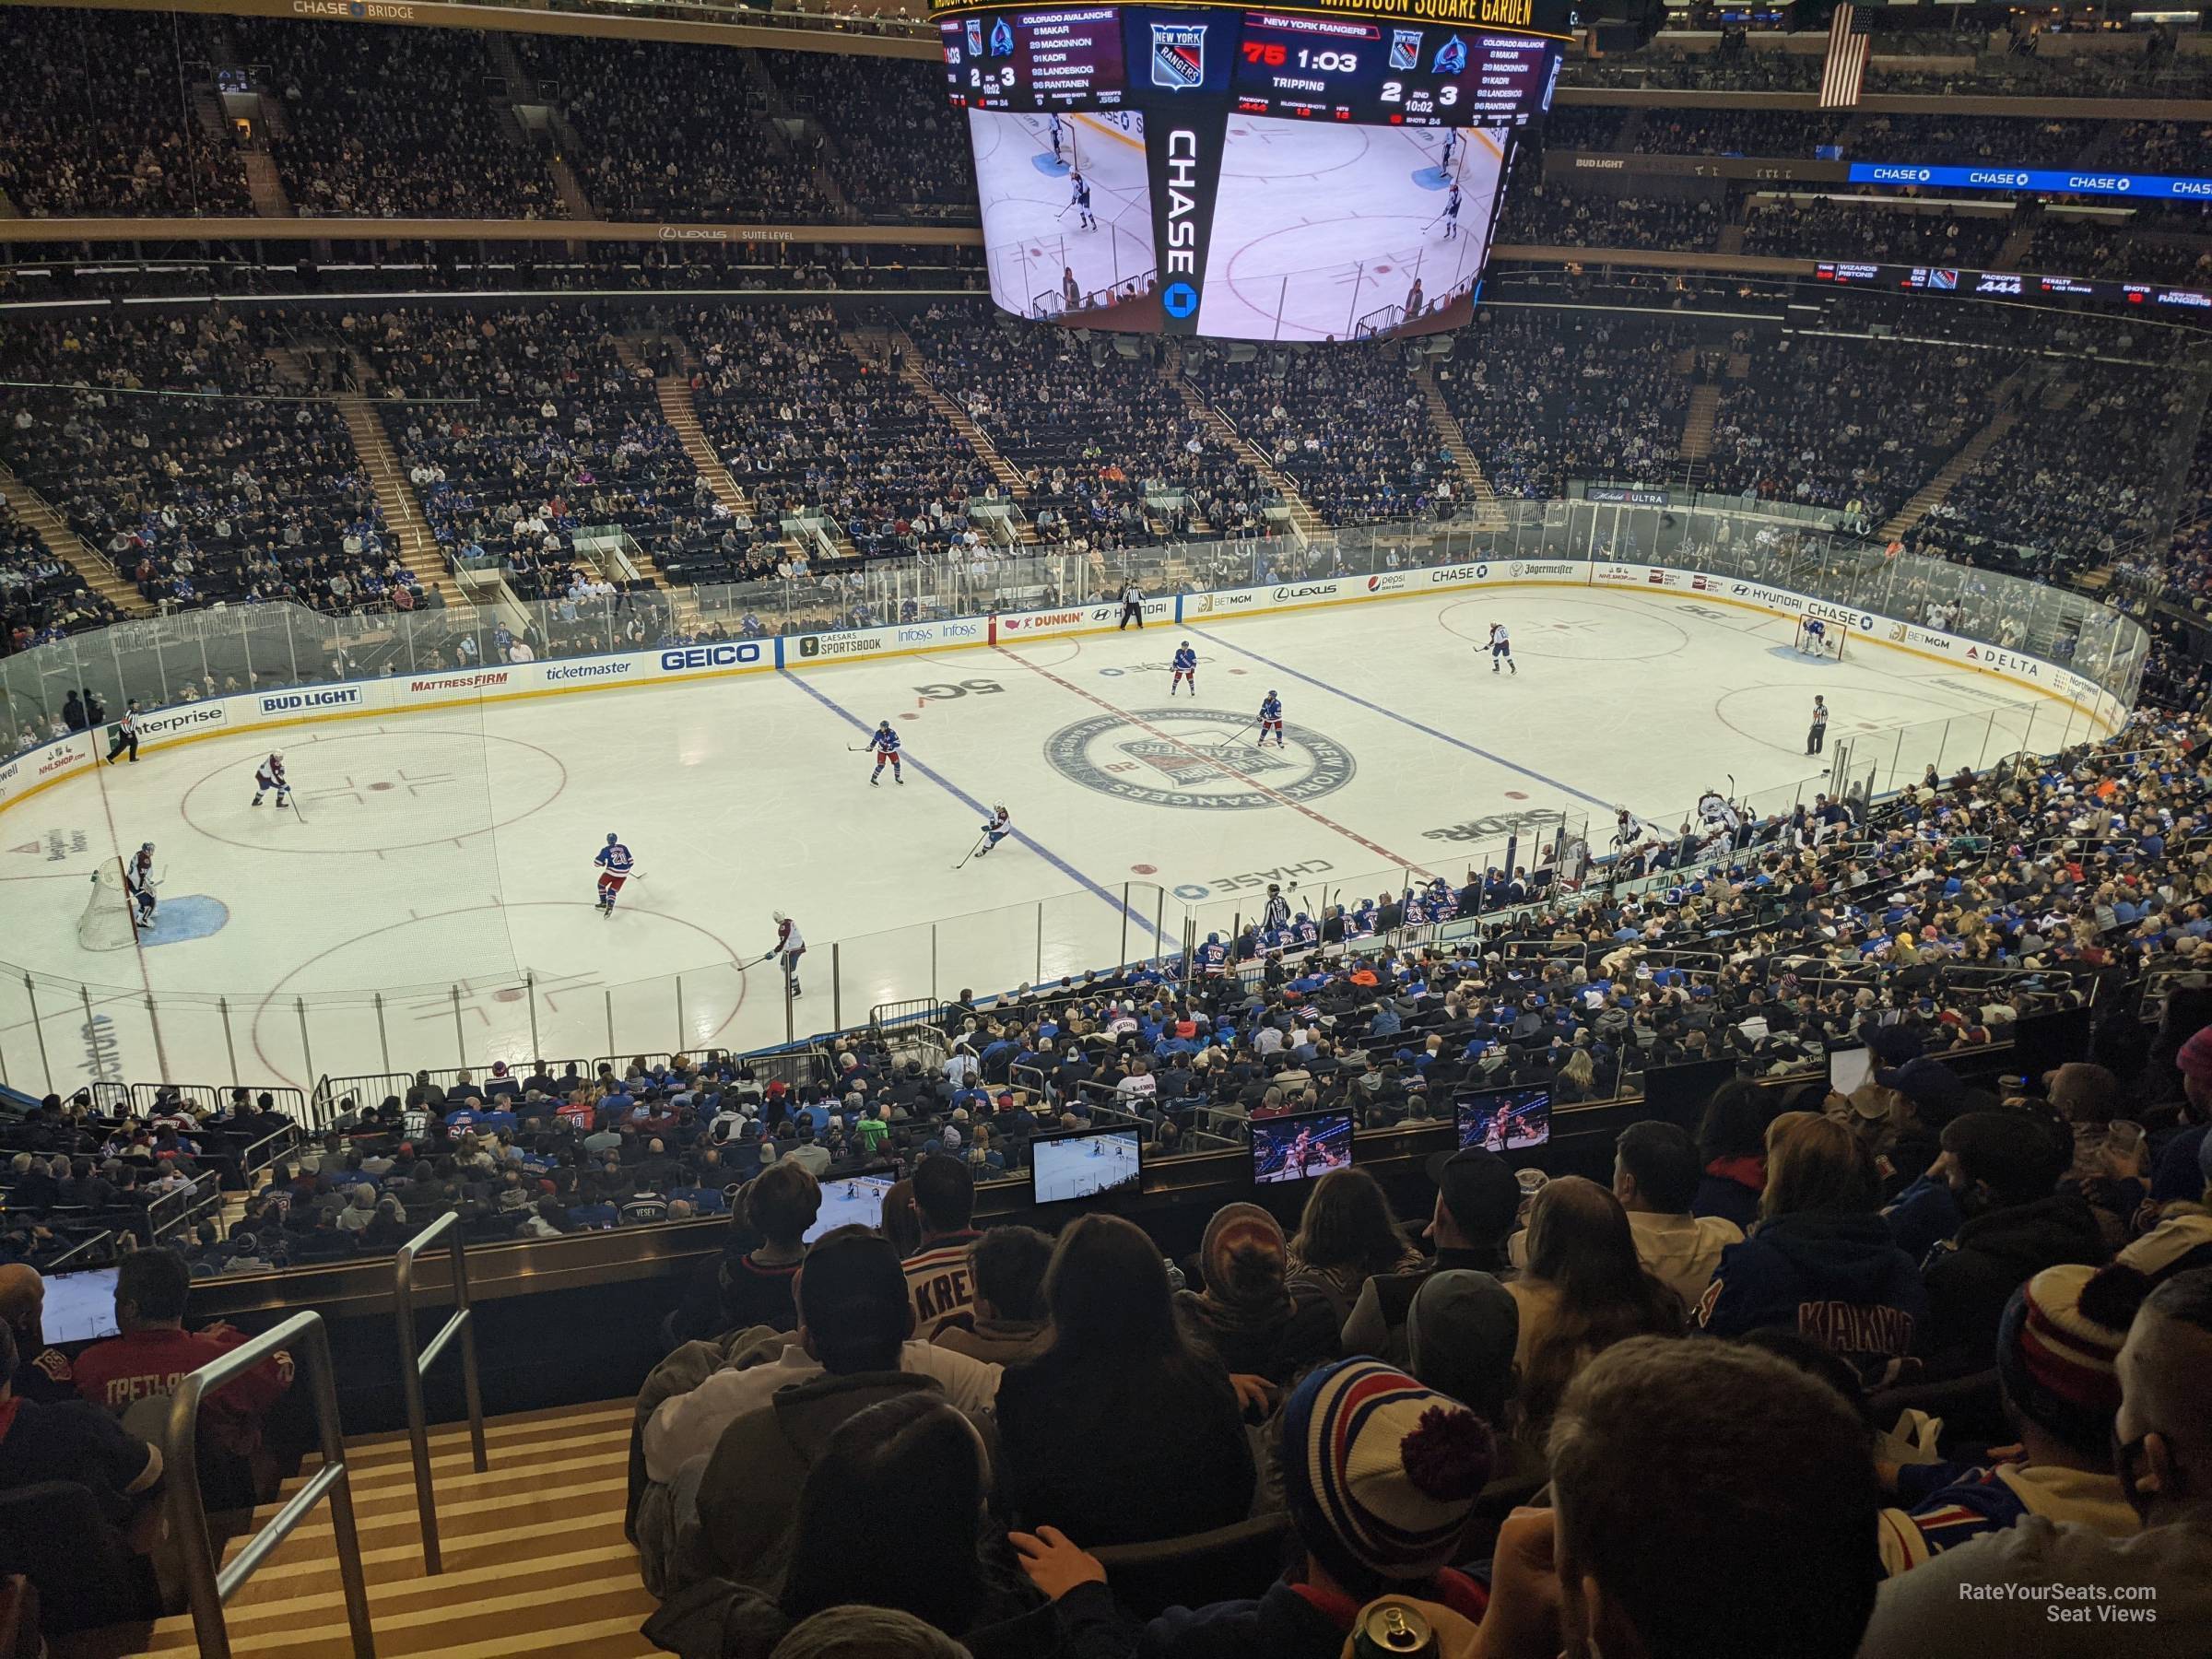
left=1183, top=347, right=1458, bottom=524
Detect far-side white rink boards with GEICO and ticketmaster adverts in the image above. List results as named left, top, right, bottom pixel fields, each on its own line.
left=0, top=559, right=2128, bottom=827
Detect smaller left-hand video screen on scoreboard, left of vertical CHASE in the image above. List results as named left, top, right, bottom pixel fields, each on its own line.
left=969, top=109, right=1157, bottom=316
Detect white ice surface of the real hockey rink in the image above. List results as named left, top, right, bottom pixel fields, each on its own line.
left=0, top=588, right=2084, bottom=1093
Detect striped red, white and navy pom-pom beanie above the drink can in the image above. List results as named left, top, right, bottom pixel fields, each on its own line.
left=1283, top=1359, right=1493, bottom=1588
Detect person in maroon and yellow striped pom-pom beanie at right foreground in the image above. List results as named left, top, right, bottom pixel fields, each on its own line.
left=1882, top=1263, right=2144, bottom=1572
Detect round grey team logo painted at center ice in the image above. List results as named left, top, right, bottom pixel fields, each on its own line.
left=1044, top=706, right=1354, bottom=812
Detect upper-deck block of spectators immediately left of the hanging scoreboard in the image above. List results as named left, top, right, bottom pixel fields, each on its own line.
left=761, top=51, right=975, bottom=223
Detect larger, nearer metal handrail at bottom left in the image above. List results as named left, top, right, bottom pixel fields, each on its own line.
left=164, top=1312, right=376, bottom=1659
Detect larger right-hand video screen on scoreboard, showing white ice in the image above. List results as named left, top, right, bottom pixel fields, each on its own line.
left=1199, top=115, right=1504, bottom=341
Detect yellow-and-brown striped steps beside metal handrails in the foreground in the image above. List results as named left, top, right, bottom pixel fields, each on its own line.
left=122, top=1400, right=654, bottom=1659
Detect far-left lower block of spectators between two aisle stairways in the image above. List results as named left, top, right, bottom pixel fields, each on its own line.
left=0, top=312, right=422, bottom=613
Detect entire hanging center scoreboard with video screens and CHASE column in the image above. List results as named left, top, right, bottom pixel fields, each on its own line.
left=935, top=0, right=1575, bottom=341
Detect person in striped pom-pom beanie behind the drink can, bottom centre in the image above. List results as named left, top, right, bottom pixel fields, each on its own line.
left=1013, top=1359, right=1493, bottom=1659
